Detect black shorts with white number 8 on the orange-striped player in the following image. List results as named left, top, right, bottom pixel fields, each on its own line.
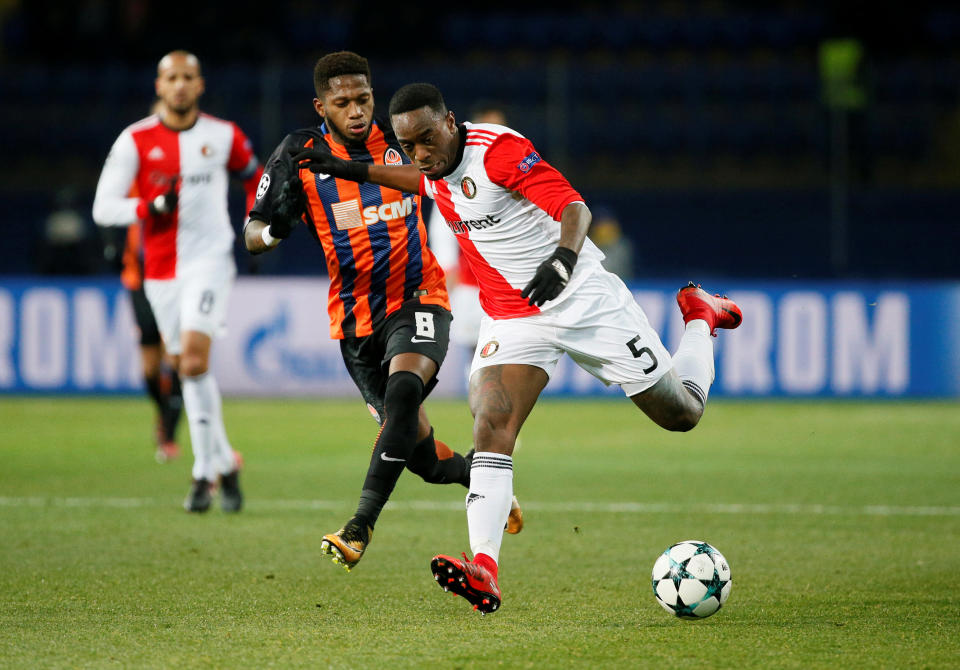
left=340, top=300, right=453, bottom=423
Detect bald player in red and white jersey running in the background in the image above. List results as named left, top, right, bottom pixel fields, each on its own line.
left=93, top=51, right=262, bottom=512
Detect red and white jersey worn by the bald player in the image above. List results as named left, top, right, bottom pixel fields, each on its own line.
left=93, top=114, right=262, bottom=279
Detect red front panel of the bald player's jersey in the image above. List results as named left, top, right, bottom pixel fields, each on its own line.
left=132, top=121, right=180, bottom=279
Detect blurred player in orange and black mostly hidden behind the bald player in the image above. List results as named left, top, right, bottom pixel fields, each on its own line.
left=101, top=99, right=183, bottom=463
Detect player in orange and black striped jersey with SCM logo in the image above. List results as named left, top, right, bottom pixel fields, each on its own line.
left=244, top=51, right=519, bottom=570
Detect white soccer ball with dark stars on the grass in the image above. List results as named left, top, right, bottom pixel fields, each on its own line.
left=653, top=540, right=731, bottom=619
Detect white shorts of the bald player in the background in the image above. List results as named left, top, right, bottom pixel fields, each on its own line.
left=143, top=256, right=237, bottom=355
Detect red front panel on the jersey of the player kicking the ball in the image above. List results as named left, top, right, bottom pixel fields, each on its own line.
left=433, top=179, right=540, bottom=319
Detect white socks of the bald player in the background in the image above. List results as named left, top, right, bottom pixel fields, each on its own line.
left=181, top=372, right=235, bottom=482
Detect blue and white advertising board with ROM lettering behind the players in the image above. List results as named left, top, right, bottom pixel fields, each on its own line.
left=0, top=277, right=960, bottom=398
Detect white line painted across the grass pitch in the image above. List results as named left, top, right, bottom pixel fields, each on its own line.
left=0, top=496, right=960, bottom=516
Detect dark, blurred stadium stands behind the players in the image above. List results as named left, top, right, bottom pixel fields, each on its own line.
left=0, top=0, right=960, bottom=279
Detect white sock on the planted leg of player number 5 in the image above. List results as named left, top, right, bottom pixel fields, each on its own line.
left=467, top=452, right=513, bottom=561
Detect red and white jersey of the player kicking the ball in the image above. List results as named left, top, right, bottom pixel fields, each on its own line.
left=420, top=123, right=603, bottom=319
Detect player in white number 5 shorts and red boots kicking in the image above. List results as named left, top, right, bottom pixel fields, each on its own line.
left=294, top=84, right=742, bottom=613
